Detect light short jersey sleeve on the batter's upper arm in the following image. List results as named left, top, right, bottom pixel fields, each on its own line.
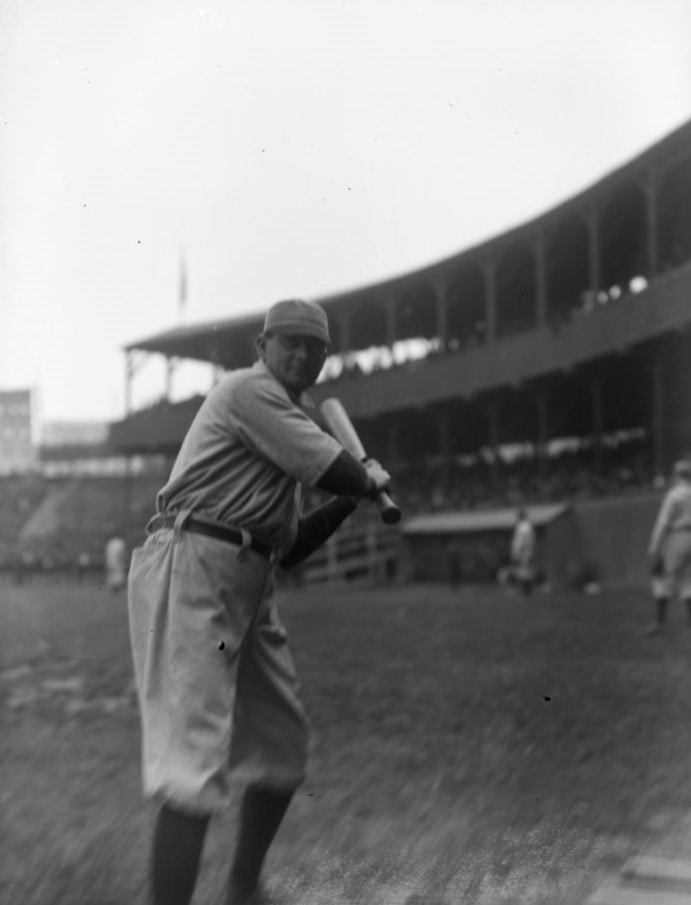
left=232, top=378, right=343, bottom=487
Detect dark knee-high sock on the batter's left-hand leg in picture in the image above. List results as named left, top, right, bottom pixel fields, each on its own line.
left=151, top=805, right=209, bottom=905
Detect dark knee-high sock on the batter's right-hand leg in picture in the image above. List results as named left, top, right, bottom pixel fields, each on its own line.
left=230, top=786, right=294, bottom=891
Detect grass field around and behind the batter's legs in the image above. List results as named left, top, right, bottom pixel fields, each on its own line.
left=0, top=586, right=691, bottom=905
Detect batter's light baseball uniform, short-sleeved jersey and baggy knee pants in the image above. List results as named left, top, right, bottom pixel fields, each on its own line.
left=129, top=362, right=342, bottom=814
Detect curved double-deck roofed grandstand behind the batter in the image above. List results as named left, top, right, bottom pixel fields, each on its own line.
left=2, top=122, right=691, bottom=582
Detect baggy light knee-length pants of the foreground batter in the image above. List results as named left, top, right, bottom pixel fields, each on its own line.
left=128, top=527, right=310, bottom=814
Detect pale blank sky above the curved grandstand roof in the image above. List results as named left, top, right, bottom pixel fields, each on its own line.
left=0, top=0, right=691, bottom=420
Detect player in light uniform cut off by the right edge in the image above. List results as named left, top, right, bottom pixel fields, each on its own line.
left=647, top=460, right=691, bottom=635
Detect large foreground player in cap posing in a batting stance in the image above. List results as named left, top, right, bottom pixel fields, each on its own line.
left=128, top=300, right=390, bottom=905
